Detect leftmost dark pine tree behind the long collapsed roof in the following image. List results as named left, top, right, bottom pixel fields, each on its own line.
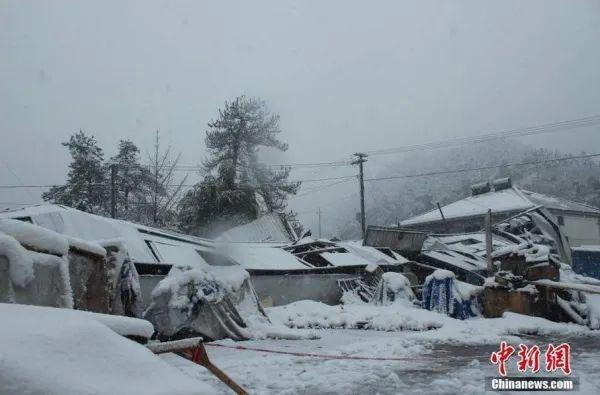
left=42, top=130, right=109, bottom=214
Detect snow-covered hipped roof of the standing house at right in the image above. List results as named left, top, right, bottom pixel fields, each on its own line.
left=400, top=187, right=600, bottom=226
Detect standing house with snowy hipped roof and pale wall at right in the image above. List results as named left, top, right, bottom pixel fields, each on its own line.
left=400, top=178, right=600, bottom=247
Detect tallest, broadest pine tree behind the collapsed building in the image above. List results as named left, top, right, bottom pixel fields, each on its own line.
left=180, top=96, right=300, bottom=235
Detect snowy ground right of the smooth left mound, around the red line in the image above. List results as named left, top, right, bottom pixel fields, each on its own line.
left=163, top=301, right=600, bottom=394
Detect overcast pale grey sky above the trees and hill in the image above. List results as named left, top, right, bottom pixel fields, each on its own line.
left=0, top=0, right=600, bottom=223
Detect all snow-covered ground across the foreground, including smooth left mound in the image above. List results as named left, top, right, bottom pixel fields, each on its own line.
left=0, top=300, right=600, bottom=394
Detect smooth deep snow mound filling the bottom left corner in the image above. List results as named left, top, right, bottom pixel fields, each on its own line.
left=0, top=304, right=215, bottom=394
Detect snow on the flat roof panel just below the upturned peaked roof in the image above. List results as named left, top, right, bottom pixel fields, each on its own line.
left=217, top=243, right=308, bottom=270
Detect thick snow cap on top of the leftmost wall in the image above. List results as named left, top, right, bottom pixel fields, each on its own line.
left=0, top=219, right=69, bottom=255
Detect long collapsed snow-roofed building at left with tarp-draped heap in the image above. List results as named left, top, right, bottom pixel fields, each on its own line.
left=0, top=205, right=407, bottom=339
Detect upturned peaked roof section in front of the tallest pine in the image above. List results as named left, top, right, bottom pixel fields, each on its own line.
left=218, top=213, right=297, bottom=243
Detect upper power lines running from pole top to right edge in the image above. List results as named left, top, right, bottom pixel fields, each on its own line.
left=366, top=115, right=600, bottom=155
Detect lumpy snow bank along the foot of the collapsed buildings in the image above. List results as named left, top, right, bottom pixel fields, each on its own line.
left=267, top=300, right=600, bottom=344
